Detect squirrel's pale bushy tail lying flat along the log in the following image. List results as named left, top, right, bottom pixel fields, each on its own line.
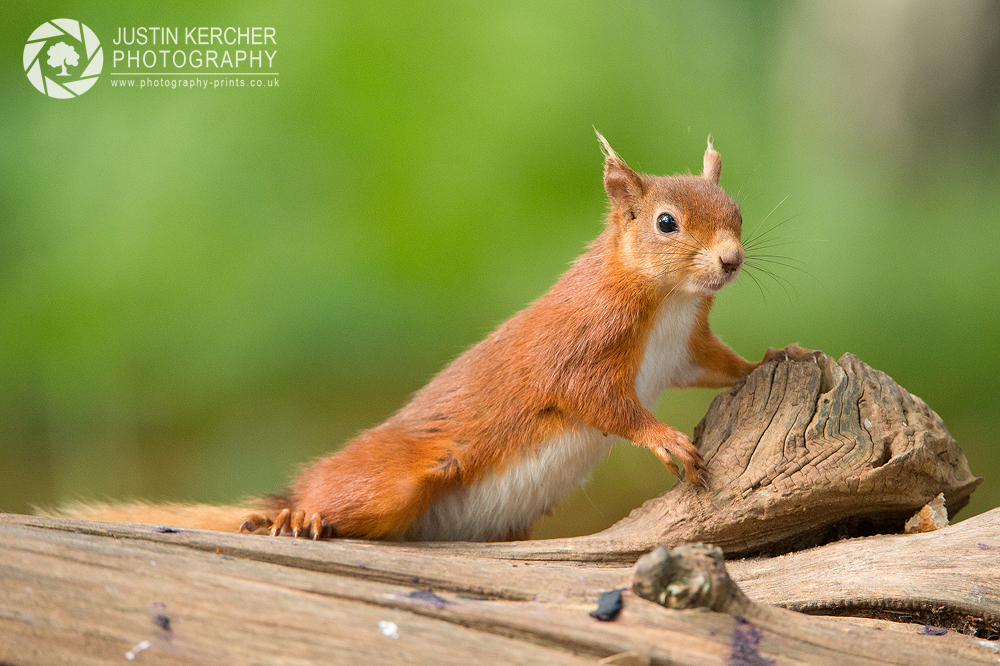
left=35, top=498, right=276, bottom=532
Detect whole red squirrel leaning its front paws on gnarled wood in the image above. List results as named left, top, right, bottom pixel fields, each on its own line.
left=54, top=133, right=818, bottom=541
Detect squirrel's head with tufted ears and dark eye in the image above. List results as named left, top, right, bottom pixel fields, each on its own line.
left=597, top=133, right=744, bottom=295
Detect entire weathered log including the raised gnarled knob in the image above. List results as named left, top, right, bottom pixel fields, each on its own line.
left=0, top=355, right=988, bottom=666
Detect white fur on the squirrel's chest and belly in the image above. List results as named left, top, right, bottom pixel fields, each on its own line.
left=406, top=297, right=700, bottom=541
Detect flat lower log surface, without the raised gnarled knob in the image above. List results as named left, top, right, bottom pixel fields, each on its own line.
left=0, top=510, right=1000, bottom=665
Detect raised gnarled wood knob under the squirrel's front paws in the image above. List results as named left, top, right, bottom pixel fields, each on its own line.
left=604, top=354, right=982, bottom=557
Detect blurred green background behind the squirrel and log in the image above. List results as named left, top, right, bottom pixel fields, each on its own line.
left=0, top=0, right=1000, bottom=536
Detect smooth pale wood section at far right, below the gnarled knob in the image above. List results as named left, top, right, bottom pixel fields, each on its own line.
left=729, top=509, right=1000, bottom=639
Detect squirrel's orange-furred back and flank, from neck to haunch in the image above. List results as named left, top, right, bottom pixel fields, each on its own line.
left=293, top=236, right=655, bottom=538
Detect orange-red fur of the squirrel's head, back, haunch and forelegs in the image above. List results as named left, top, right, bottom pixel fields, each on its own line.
left=292, top=134, right=756, bottom=538
